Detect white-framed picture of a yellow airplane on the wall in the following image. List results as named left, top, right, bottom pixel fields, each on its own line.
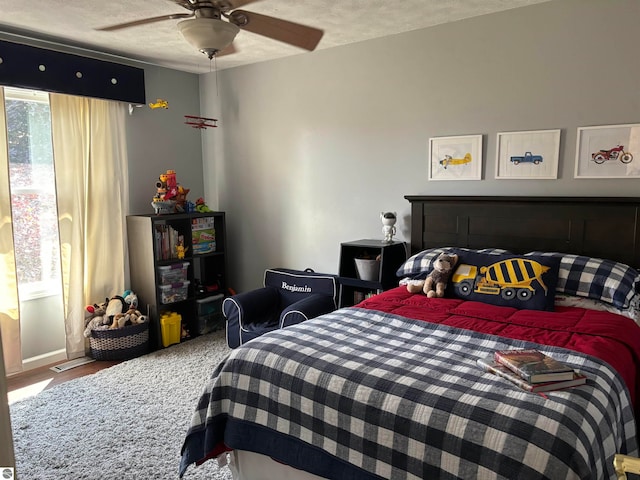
left=428, top=135, right=482, bottom=180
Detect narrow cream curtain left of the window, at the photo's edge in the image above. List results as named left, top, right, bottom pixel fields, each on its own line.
left=0, top=88, right=22, bottom=374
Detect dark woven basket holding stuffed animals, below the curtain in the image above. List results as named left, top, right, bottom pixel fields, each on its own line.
left=89, top=322, right=149, bottom=360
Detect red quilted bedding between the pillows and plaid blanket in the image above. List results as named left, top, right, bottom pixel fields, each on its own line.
left=357, top=286, right=640, bottom=411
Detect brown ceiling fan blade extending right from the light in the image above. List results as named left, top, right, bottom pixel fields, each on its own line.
left=229, top=10, right=324, bottom=50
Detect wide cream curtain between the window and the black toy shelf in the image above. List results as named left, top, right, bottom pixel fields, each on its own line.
left=49, top=94, right=129, bottom=359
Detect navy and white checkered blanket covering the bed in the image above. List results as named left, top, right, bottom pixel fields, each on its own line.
left=180, top=308, right=637, bottom=480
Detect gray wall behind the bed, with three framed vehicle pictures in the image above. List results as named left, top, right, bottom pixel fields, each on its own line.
left=200, top=0, right=640, bottom=291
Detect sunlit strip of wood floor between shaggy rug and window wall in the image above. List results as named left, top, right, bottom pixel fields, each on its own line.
left=7, top=360, right=121, bottom=403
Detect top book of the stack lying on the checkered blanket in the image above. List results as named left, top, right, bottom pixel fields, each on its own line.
left=494, top=349, right=574, bottom=383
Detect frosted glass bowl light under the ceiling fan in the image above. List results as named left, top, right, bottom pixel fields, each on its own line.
left=178, top=17, right=240, bottom=58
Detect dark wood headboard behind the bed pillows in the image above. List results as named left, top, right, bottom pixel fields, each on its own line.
left=404, top=195, right=640, bottom=267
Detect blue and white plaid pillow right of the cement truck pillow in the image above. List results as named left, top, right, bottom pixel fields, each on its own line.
left=527, top=252, right=640, bottom=309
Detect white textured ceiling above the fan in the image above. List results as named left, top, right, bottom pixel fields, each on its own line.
left=0, top=0, right=549, bottom=73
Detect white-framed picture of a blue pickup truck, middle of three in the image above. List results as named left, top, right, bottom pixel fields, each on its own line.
left=496, top=129, right=561, bottom=180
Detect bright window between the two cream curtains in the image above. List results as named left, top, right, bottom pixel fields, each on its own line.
left=5, top=88, right=61, bottom=300
